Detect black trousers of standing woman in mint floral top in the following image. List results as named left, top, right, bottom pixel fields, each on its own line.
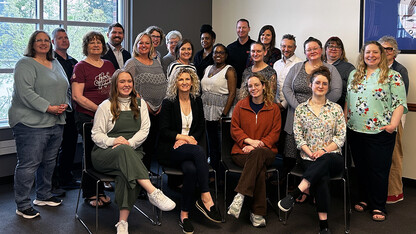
left=347, top=129, right=396, bottom=212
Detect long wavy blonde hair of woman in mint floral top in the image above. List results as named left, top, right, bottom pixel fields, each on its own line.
left=351, top=41, right=390, bottom=89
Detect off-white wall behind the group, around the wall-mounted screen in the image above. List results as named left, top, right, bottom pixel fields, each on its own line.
left=212, top=0, right=416, bottom=179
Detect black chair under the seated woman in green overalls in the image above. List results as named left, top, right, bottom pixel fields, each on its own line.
left=75, top=122, right=160, bottom=233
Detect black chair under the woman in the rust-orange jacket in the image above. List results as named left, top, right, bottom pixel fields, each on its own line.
left=220, top=118, right=280, bottom=222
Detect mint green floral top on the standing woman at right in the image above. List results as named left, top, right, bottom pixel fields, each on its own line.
left=345, top=69, right=407, bottom=134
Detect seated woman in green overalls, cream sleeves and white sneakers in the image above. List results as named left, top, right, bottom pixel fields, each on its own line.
left=91, top=69, right=176, bottom=233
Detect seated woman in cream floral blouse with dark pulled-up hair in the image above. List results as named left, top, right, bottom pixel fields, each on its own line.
left=278, top=66, right=346, bottom=233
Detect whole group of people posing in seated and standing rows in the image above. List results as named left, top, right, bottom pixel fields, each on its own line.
left=9, top=19, right=409, bottom=233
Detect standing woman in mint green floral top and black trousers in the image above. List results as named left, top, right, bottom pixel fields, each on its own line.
left=345, top=41, right=407, bottom=221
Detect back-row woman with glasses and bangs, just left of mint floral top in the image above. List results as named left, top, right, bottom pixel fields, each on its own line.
left=324, top=37, right=355, bottom=107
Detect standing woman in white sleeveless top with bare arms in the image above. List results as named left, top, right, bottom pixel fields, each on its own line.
left=201, top=44, right=237, bottom=170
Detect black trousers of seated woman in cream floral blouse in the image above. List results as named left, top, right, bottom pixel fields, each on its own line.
left=302, top=153, right=344, bottom=213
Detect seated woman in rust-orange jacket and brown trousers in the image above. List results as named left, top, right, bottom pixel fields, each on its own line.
left=227, top=73, right=281, bottom=227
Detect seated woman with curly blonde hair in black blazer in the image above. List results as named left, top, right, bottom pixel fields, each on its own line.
left=158, top=68, right=221, bottom=233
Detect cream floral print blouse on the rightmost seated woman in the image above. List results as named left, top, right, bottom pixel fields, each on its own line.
left=293, top=99, right=346, bottom=161
